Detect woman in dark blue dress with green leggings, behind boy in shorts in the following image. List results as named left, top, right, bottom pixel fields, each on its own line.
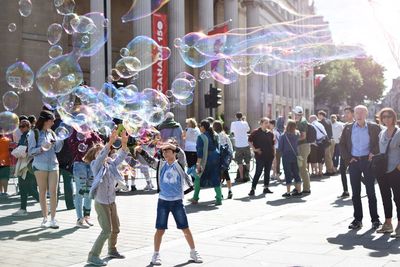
left=190, top=120, right=222, bottom=205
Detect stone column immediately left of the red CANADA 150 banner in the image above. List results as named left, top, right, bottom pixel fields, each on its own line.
left=132, top=1, right=153, bottom=90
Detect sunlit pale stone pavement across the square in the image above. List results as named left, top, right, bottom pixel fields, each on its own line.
left=0, top=171, right=400, bottom=267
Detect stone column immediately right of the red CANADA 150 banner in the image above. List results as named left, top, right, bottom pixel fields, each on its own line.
left=168, top=0, right=187, bottom=127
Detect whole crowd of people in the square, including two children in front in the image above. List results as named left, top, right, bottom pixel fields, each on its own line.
left=0, top=103, right=400, bottom=266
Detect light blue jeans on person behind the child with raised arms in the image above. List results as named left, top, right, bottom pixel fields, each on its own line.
left=73, top=162, right=93, bottom=219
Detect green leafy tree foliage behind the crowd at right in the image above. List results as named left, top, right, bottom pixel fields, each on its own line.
left=314, top=58, right=385, bottom=112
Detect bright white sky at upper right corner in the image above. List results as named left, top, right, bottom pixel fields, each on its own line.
left=310, top=0, right=400, bottom=91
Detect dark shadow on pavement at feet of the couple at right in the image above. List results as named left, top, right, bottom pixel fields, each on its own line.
left=327, top=229, right=400, bottom=258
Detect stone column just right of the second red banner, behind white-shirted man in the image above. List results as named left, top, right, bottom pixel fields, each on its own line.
left=224, top=0, right=241, bottom=126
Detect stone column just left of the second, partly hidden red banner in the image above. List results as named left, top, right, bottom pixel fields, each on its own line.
left=197, top=0, right=214, bottom=120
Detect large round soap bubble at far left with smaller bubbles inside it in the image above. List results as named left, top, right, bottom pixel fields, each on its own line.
left=36, top=54, right=83, bottom=97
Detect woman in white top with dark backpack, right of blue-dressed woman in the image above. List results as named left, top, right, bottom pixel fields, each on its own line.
left=213, top=121, right=233, bottom=199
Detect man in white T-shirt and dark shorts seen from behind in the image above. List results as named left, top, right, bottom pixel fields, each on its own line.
left=230, top=112, right=251, bottom=182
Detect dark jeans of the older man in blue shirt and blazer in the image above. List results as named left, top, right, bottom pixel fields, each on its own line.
left=349, top=159, right=379, bottom=222
